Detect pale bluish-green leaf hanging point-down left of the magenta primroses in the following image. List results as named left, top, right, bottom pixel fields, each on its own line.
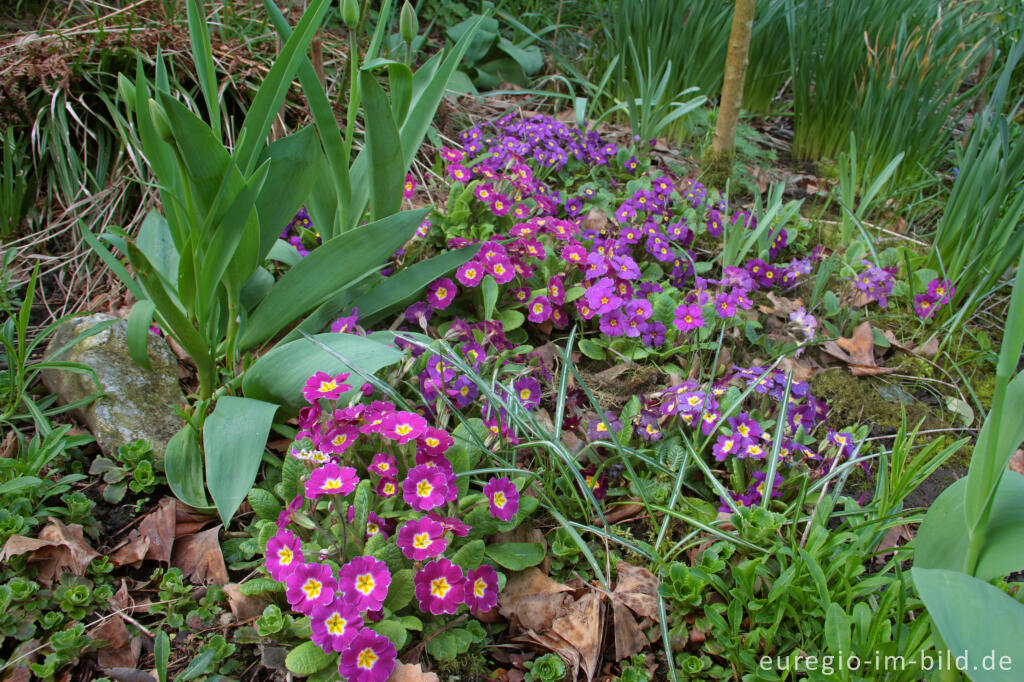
left=203, top=395, right=278, bottom=527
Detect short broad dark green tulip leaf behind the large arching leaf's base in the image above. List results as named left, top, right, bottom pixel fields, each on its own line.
left=256, top=126, right=319, bottom=258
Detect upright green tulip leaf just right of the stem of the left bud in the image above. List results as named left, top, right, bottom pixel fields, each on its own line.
left=359, top=70, right=406, bottom=220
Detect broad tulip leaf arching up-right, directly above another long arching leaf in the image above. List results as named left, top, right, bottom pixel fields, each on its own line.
left=240, top=209, right=427, bottom=350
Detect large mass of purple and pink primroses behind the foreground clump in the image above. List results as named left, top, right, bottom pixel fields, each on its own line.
left=411, top=116, right=813, bottom=348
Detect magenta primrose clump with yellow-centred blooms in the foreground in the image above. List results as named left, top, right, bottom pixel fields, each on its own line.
left=266, top=372, right=520, bottom=682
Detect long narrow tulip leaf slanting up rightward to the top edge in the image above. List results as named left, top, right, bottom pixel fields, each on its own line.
left=234, top=0, right=331, bottom=174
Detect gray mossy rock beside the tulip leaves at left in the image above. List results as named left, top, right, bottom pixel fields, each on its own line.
left=43, top=313, right=185, bottom=457
